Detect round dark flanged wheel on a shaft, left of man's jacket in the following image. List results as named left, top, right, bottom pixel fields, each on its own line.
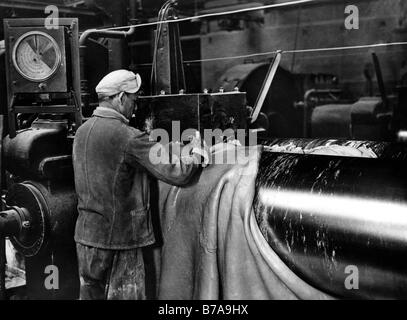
left=0, top=181, right=76, bottom=257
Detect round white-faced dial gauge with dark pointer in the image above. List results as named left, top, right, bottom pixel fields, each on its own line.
left=12, top=31, right=61, bottom=81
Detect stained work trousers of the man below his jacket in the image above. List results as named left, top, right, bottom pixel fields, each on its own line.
left=76, top=243, right=145, bottom=300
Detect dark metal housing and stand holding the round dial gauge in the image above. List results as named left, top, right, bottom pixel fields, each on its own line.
left=4, top=19, right=82, bottom=138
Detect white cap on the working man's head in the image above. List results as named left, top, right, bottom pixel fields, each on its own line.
left=95, top=69, right=141, bottom=97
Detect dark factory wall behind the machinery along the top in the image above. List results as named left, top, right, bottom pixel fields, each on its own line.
left=0, top=0, right=407, bottom=96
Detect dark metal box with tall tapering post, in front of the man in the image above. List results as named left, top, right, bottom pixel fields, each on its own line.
left=133, top=1, right=248, bottom=143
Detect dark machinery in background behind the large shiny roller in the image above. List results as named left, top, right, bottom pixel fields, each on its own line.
left=217, top=53, right=407, bottom=141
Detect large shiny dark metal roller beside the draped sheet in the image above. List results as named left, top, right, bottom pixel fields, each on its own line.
left=254, top=140, right=407, bottom=298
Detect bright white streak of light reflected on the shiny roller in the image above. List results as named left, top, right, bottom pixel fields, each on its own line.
left=259, top=188, right=407, bottom=243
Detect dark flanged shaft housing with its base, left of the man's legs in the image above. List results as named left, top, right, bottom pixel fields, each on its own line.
left=0, top=181, right=79, bottom=299
